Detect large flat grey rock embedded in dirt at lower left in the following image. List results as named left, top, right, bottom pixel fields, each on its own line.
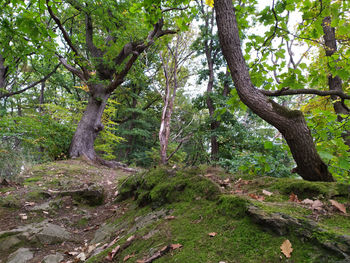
left=0, top=221, right=74, bottom=251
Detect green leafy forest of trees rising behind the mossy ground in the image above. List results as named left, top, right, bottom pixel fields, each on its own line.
left=0, top=0, right=350, bottom=182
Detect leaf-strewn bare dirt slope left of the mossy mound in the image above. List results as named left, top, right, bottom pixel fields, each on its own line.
left=0, top=160, right=128, bottom=262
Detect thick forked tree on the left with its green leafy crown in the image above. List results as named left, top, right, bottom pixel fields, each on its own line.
left=42, top=0, right=185, bottom=160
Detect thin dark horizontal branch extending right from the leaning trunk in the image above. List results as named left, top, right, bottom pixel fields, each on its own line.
left=259, top=88, right=350, bottom=100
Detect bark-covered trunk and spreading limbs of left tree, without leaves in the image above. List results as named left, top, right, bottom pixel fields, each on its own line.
left=46, top=0, right=175, bottom=161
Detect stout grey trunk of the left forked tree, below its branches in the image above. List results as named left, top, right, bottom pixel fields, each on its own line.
left=69, top=84, right=110, bottom=161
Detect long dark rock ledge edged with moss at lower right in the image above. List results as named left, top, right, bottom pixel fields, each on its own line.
left=247, top=206, right=350, bottom=262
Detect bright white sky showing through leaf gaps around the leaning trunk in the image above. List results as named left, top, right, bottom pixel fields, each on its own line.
left=184, top=0, right=310, bottom=98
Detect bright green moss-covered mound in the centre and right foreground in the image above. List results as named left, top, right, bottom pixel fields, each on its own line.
left=87, top=167, right=350, bottom=263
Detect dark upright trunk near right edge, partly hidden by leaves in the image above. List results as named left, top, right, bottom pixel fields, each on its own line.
left=322, top=16, right=350, bottom=147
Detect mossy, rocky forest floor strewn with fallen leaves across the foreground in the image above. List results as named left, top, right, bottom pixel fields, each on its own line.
left=0, top=160, right=350, bottom=263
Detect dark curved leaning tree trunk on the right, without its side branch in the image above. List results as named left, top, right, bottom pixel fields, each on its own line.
left=214, top=0, right=334, bottom=181
